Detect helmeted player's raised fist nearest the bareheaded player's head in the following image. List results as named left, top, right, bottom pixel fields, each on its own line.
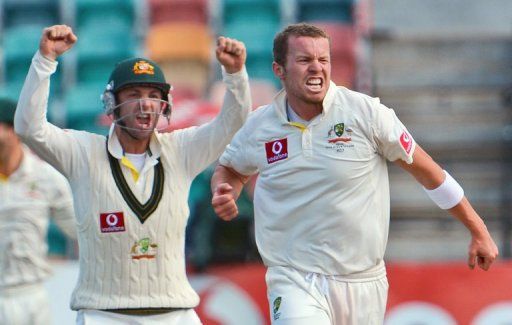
left=215, top=36, right=247, bottom=73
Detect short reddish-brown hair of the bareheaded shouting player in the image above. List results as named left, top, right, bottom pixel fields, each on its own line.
left=273, top=23, right=331, bottom=66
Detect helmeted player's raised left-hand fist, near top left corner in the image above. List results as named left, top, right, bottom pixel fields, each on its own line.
left=39, top=25, right=78, bottom=61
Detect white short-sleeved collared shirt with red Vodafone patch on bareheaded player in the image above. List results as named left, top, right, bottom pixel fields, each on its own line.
left=220, top=82, right=415, bottom=275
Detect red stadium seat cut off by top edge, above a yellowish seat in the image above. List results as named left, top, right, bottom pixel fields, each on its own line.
left=147, top=0, right=208, bottom=25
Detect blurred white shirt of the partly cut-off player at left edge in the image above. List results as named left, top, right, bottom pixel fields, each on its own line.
left=0, top=146, right=77, bottom=286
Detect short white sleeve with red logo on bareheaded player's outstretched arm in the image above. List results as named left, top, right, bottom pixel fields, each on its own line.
left=372, top=99, right=416, bottom=164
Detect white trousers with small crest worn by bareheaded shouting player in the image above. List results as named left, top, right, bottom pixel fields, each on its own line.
left=265, top=266, right=389, bottom=325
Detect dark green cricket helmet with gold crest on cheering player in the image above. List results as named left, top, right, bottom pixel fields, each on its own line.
left=102, top=58, right=171, bottom=114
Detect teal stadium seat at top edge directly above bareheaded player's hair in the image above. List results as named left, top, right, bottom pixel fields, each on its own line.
left=297, top=0, right=355, bottom=23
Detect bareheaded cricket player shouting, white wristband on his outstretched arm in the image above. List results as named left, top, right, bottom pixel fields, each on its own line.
left=212, top=24, right=498, bottom=325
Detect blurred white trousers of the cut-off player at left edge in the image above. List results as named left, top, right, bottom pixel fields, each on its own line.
left=0, top=283, right=51, bottom=325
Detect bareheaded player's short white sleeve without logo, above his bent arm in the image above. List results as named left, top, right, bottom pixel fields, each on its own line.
left=219, top=127, right=258, bottom=176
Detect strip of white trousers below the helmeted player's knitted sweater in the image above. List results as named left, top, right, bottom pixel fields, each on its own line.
left=76, top=309, right=202, bottom=325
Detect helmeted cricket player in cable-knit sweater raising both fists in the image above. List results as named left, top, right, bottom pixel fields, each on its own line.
left=15, top=25, right=251, bottom=324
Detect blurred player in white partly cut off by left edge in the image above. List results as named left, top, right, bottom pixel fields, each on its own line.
left=0, top=98, right=76, bottom=325
